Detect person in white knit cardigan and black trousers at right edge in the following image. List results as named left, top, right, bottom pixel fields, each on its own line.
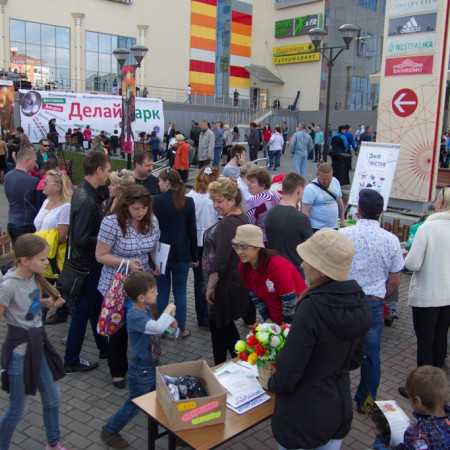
left=405, top=187, right=450, bottom=367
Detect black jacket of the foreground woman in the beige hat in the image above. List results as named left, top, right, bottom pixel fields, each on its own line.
left=269, top=280, right=372, bottom=448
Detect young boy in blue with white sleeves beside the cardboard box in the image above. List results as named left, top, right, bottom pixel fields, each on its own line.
left=101, top=272, right=177, bottom=448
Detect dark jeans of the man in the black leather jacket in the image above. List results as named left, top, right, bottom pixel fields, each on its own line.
left=64, top=266, right=108, bottom=366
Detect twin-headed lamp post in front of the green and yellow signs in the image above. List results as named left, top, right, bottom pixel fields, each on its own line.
left=308, top=23, right=359, bottom=162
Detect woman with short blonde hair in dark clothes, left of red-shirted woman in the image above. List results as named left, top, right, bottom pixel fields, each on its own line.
left=202, top=177, right=250, bottom=364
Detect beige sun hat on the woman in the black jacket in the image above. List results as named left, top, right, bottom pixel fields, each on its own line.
left=297, top=228, right=355, bottom=281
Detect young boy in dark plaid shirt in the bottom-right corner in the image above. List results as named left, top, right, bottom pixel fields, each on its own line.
left=374, top=366, right=450, bottom=450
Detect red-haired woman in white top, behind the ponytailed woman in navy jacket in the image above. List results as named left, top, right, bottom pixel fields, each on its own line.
left=186, top=166, right=219, bottom=327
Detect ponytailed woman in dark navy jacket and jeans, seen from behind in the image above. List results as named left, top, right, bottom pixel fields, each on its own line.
left=153, top=169, right=198, bottom=338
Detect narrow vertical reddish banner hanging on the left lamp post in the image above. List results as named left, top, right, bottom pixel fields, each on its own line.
left=121, top=65, right=136, bottom=153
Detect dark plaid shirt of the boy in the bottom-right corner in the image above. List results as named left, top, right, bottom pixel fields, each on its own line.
left=373, top=405, right=450, bottom=450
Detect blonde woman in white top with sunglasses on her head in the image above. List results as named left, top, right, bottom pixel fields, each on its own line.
left=34, top=170, right=73, bottom=244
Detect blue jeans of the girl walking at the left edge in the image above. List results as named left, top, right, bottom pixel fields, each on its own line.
left=0, top=353, right=60, bottom=450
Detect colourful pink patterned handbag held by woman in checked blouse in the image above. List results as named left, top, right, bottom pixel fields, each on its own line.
left=97, top=259, right=130, bottom=336
